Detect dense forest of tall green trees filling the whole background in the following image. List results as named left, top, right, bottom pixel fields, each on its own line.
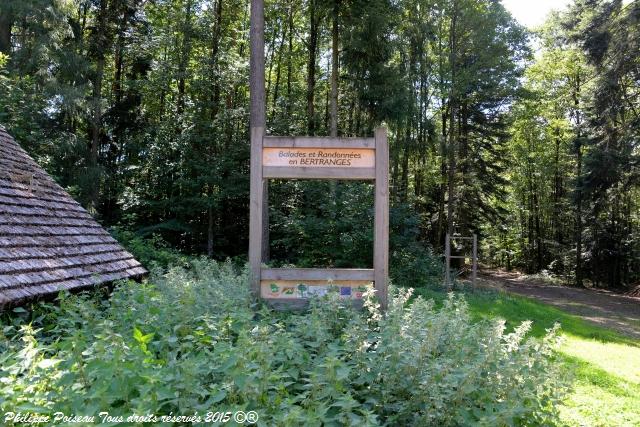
left=0, top=0, right=640, bottom=289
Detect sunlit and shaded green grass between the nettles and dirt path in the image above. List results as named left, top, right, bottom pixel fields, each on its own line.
left=416, top=288, right=640, bottom=426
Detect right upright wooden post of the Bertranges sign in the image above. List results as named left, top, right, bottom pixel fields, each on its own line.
left=373, top=127, right=389, bottom=311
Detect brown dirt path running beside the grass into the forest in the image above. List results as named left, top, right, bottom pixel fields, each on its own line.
left=478, top=270, right=640, bottom=340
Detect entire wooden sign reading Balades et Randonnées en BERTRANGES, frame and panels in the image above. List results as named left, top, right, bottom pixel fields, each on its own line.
left=249, top=127, right=389, bottom=309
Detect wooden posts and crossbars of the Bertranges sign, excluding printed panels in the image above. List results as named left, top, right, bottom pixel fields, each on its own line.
left=249, top=127, right=389, bottom=310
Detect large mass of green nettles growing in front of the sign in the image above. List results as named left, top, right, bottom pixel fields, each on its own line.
left=0, top=260, right=564, bottom=426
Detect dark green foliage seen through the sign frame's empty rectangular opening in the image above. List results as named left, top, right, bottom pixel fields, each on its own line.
left=269, top=181, right=373, bottom=268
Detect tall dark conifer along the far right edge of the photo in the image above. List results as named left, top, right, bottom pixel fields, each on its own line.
left=564, top=0, right=640, bottom=288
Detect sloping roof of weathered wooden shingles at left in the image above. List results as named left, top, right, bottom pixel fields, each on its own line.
left=0, top=126, right=146, bottom=307
